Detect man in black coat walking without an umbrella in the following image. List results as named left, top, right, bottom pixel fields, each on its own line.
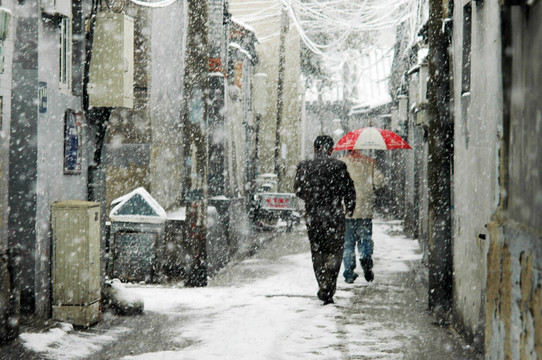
left=294, top=135, right=356, bottom=305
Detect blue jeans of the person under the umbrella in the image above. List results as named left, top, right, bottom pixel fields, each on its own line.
left=343, top=219, right=374, bottom=279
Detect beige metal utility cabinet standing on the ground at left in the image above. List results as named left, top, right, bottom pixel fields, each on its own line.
left=51, top=200, right=101, bottom=326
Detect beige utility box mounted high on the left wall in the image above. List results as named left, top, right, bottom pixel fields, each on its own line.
left=88, top=12, right=134, bottom=109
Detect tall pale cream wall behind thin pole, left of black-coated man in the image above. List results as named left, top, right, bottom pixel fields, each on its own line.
left=229, top=0, right=304, bottom=191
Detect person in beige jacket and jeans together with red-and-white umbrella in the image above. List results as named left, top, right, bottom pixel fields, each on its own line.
left=334, top=127, right=410, bottom=284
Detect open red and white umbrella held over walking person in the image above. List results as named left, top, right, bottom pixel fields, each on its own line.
left=333, top=127, right=411, bottom=151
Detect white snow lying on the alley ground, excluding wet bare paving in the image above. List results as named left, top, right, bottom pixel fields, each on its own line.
left=20, top=222, right=438, bottom=360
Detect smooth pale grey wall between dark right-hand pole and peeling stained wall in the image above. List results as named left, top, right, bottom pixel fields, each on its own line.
left=453, top=1, right=502, bottom=347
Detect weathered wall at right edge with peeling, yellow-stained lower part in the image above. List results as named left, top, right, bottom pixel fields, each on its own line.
left=485, top=1, right=542, bottom=359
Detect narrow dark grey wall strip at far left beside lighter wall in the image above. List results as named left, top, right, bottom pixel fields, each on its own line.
left=9, top=4, right=39, bottom=312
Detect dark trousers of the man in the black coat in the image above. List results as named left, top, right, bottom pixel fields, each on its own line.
left=307, top=217, right=344, bottom=301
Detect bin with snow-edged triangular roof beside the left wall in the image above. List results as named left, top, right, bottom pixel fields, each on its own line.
left=108, top=187, right=166, bottom=282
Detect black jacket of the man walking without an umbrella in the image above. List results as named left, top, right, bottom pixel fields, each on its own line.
left=294, top=153, right=356, bottom=221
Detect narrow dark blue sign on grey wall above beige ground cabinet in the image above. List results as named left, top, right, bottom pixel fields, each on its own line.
left=64, top=109, right=83, bottom=174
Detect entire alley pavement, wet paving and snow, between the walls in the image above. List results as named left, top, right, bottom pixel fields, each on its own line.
left=0, top=220, right=483, bottom=360
